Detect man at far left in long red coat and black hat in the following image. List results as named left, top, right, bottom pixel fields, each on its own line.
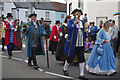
left=4, top=13, right=17, bottom=59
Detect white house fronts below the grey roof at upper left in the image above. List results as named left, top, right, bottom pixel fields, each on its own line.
left=4, top=2, right=56, bottom=26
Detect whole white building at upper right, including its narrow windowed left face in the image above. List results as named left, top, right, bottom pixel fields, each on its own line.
left=66, top=0, right=120, bottom=30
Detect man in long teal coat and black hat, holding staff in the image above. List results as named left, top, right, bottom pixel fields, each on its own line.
left=23, top=13, right=46, bottom=70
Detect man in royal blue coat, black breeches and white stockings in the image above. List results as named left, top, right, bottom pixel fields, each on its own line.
left=63, top=9, right=87, bottom=80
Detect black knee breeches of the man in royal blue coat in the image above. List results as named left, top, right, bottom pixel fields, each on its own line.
left=67, top=47, right=85, bottom=63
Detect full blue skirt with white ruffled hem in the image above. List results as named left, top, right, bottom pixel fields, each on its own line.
left=86, top=43, right=115, bottom=75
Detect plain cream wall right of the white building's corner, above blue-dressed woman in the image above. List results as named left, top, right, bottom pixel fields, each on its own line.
left=84, top=2, right=118, bottom=26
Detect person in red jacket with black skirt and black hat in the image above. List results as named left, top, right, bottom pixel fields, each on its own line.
left=49, top=21, right=61, bottom=54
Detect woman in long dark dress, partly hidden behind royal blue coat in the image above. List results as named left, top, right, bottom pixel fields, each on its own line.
left=55, top=15, right=71, bottom=61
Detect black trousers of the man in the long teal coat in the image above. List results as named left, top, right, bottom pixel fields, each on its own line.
left=28, top=47, right=37, bottom=66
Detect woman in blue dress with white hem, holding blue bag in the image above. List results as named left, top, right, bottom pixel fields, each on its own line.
left=86, top=20, right=116, bottom=75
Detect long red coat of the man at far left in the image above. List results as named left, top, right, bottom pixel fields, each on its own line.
left=5, top=21, right=17, bottom=46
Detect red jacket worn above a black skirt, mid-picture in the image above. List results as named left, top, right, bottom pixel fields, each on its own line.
left=50, top=25, right=61, bottom=42
